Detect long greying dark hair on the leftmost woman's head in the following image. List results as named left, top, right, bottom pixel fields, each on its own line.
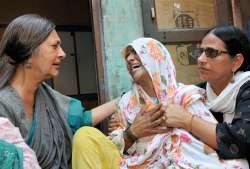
left=0, top=14, right=55, bottom=65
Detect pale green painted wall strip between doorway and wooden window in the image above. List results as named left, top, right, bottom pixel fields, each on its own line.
left=101, top=0, right=143, bottom=99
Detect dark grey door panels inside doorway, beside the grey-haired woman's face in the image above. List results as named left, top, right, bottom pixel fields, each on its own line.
left=53, top=27, right=98, bottom=109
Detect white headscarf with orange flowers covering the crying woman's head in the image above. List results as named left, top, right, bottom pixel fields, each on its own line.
left=127, top=38, right=177, bottom=99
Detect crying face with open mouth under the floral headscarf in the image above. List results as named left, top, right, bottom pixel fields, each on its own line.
left=126, top=50, right=151, bottom=84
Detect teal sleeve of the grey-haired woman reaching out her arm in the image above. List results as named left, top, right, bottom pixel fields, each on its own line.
left=67, top=98, right=92, bottom=133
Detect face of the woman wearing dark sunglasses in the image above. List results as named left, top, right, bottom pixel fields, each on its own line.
left=198, top=34, right=233, bottom=83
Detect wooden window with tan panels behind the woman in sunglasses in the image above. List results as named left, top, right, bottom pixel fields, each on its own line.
left=142, top=0, right=233, bottom=84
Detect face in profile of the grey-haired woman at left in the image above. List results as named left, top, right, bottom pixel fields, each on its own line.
left=30, top=30, right=65, bottom=80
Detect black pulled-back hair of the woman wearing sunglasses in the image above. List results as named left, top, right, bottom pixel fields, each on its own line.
left=207, top=26, right=250, bottom=71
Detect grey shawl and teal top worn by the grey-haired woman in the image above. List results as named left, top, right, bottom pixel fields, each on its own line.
left=0, top=83, right=92, bottom=169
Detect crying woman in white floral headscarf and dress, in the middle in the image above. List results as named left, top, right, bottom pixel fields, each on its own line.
left=104, top=38, right=249, bottom=169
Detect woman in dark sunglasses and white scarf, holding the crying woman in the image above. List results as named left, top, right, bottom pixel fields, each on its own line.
left=165, top=26, right=250, bottom=161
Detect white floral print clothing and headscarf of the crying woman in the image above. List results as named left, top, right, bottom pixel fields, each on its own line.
left=110, top=38, right=248, bottom=169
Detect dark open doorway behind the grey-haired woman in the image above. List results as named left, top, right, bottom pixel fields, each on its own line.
left=0, top=0, right=103, bottom=109
